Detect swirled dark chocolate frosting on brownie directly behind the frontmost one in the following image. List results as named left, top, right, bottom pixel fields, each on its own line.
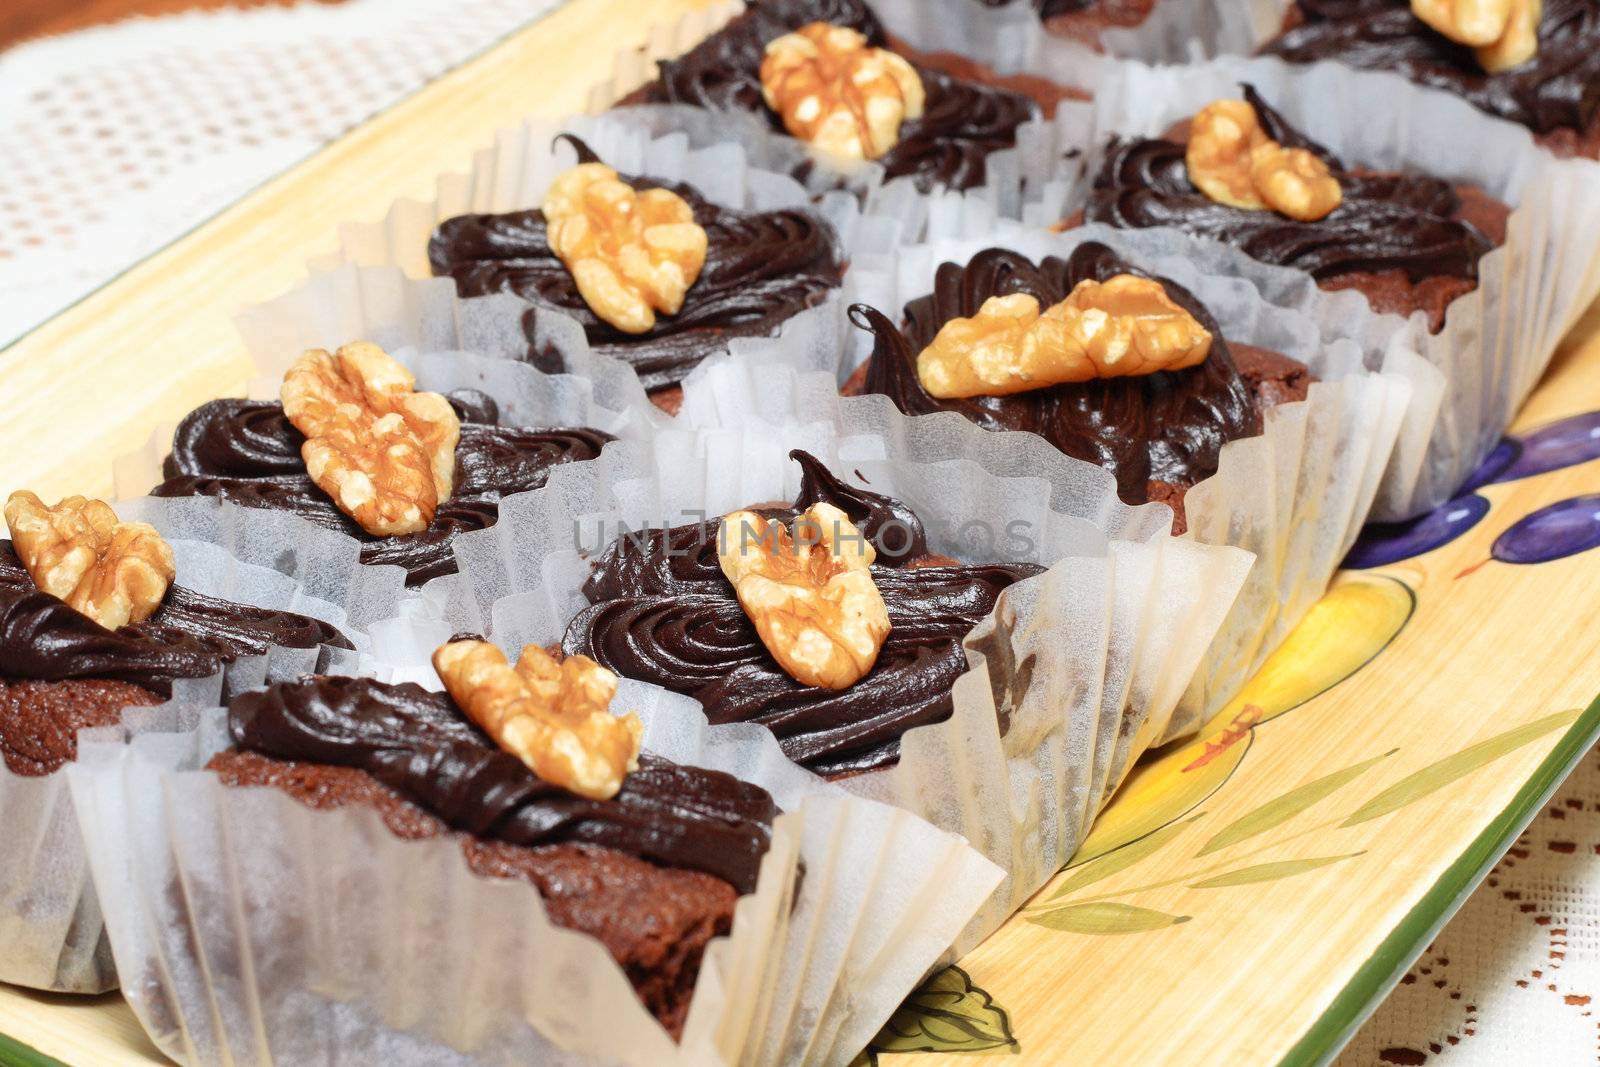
left=562, top=451, right=1043, bottom=776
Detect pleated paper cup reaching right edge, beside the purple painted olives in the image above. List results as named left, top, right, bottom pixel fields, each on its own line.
left=1085, top=58, right=1600, bottom=520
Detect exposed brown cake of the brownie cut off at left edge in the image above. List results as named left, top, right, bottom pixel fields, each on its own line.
left=0, top=678, right=166, bottom=777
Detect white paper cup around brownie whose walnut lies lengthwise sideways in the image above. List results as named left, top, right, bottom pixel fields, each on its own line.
left=680, top=226, right=1429, bottom=742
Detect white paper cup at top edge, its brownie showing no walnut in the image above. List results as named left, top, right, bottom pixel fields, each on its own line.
left=867, top=0, right=1286, bottom=75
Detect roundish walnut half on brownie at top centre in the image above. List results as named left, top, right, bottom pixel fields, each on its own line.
left=762, top=22, right=923, bottom=160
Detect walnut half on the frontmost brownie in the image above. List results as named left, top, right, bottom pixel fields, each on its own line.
left=434, top=641, right=645, bottom=800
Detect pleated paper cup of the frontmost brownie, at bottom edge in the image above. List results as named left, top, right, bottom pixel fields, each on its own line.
left=70, top=705, right=1002, bottom=1067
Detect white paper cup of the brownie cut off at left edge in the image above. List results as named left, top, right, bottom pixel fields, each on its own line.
left=0, top=501, right=360, bottom=993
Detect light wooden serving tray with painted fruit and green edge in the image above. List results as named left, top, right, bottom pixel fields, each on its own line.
left=0, top=0, right=1600, bottom=1067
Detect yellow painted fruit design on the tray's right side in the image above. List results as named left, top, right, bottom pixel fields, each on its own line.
left=1072, top=573, right=1416, bottom=865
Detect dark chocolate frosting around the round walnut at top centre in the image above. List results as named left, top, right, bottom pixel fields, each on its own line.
left=629, top=0, right=1038, bottom=190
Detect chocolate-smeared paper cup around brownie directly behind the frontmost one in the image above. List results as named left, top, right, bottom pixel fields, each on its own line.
left=422, top=425, right=1250, bottom=947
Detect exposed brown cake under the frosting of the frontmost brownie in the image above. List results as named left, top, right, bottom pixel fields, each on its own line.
left=206, top=752, right=738, bottom=1038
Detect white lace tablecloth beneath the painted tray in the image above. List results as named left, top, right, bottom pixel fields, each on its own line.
left=0, top=0, right=1600, bottom=1067
